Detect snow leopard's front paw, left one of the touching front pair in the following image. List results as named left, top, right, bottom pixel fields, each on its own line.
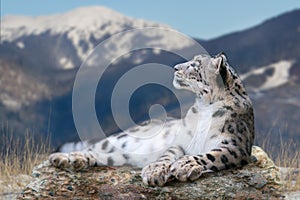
left=142, top=162, right=171, bottom=186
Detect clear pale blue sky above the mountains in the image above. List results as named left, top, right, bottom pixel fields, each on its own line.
left=0, top=0, right=300, bottom=39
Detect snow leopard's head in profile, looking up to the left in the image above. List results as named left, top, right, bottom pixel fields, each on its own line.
left=173, top=53, right=242, bottom=97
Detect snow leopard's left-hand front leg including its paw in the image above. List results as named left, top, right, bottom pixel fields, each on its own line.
left=142, top=146, right=185, bottom=186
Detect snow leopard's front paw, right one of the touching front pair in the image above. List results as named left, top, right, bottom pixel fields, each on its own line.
left=170, top=155, right=203, bottom=181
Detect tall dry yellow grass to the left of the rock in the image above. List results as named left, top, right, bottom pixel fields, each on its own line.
left=0, top=126, right=50, bottom=194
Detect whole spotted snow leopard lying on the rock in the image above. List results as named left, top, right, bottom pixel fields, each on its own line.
left=49, top=53, right=254, bottom=186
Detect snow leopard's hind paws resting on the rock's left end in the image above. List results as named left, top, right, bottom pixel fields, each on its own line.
left=49, top=152, right=96, bottom=171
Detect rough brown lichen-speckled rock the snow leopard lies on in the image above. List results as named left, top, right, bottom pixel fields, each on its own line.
left=17, top=147, right=282, bottom=199
